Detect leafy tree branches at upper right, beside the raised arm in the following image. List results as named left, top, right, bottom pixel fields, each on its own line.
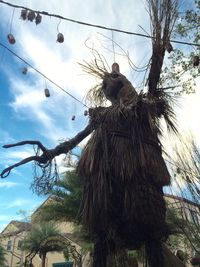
left=161, top=0, right=200, bottom=94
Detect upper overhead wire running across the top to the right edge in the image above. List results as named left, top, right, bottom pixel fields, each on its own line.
left=0, top=0, right=200, bottom=47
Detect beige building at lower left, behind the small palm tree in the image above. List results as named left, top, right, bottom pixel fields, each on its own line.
left=0, top=221, right=90, bottom=267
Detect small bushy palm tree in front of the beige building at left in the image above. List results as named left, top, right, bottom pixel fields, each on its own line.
left=22, top=222, right=63, bottom=267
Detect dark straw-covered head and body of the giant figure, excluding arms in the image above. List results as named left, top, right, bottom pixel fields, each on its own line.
left=78, top=63, right=174, bottom=266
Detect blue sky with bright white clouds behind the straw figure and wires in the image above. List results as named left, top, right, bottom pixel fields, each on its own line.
left=0, top=0, right=200, bottom=231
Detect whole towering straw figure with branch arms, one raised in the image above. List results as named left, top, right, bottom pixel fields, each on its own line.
left=1, top=0, right=183, bottom=267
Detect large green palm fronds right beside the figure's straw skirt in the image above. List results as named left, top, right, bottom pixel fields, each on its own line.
left=36, top=170, right=92, bottom=254
